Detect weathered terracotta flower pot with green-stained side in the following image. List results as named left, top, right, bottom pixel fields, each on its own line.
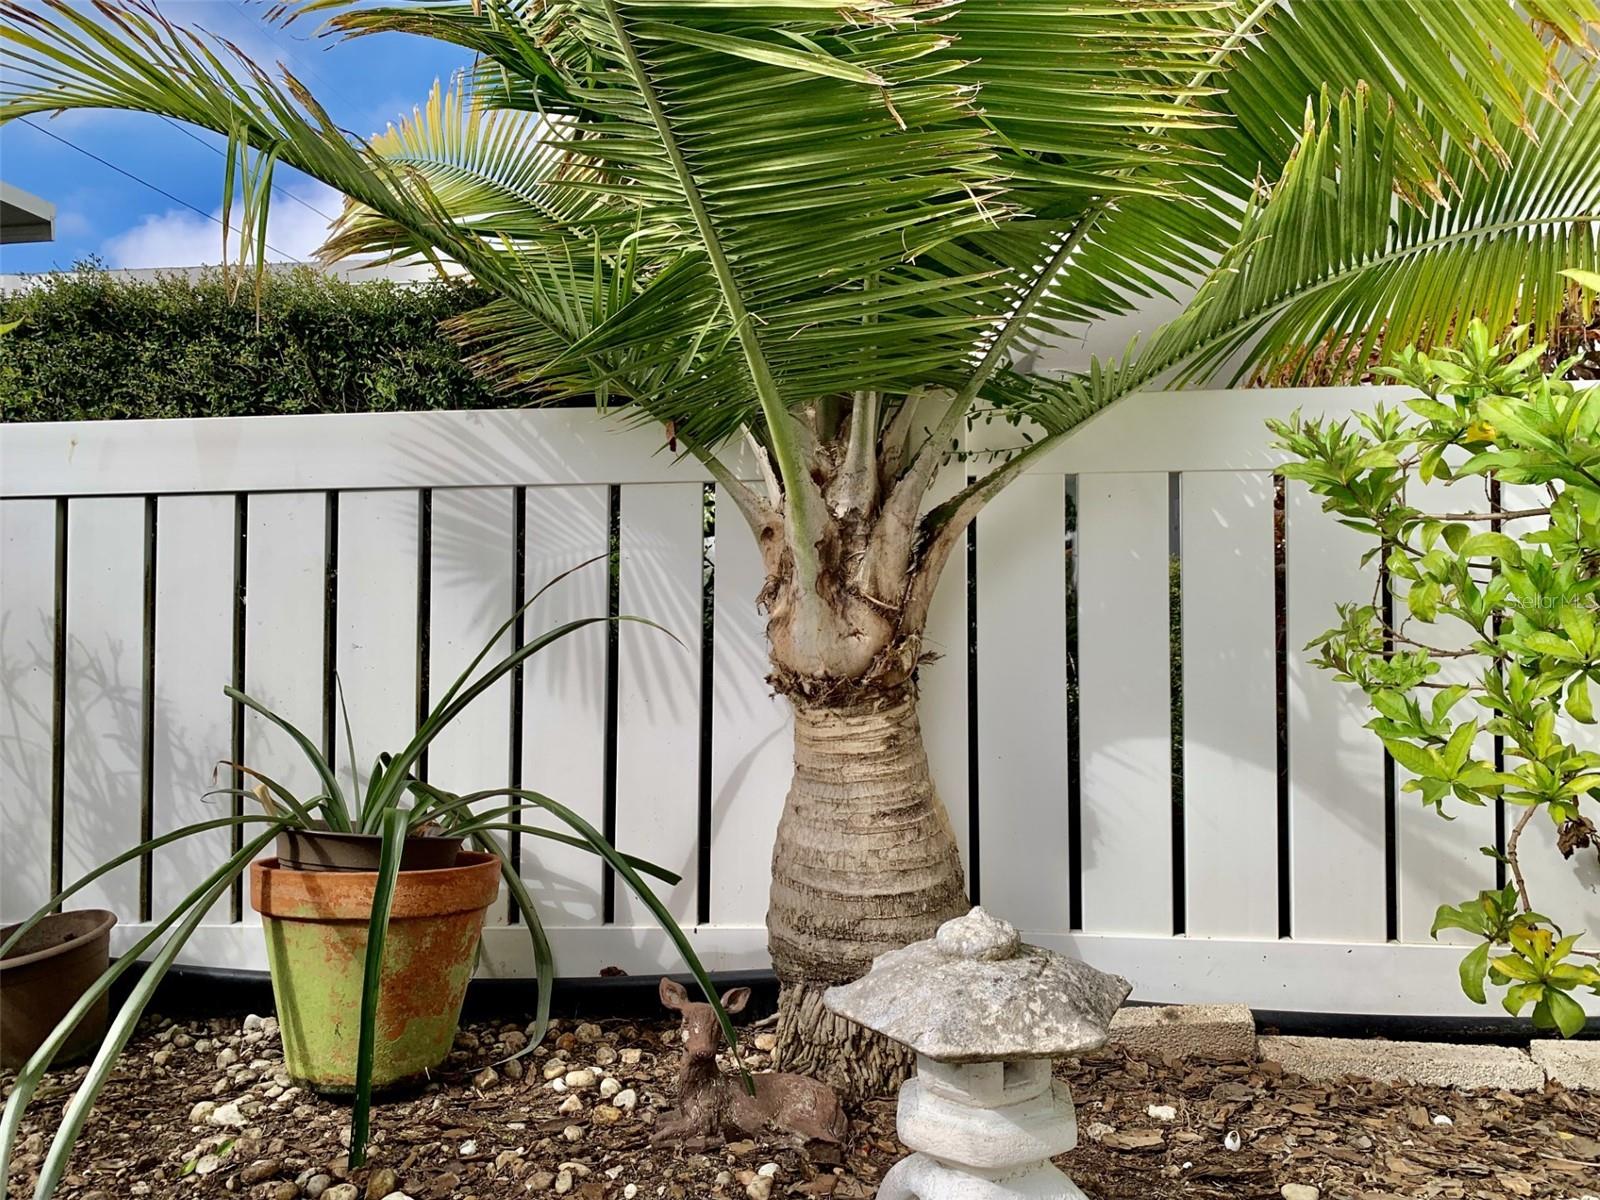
left=250, top=851, right=499, bottom=1093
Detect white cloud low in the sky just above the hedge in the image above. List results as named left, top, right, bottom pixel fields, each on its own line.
left=101, top=184, right=342, bottom=267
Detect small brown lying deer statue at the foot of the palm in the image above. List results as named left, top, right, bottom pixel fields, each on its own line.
left=651, top=979, right=848, bottom=1150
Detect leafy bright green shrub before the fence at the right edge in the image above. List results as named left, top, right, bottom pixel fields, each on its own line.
left=1270, top=315, right=1600, bottom=1037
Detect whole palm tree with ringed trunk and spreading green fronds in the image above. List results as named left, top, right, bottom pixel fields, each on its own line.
left=0, top=0, right=1600, bottom=1090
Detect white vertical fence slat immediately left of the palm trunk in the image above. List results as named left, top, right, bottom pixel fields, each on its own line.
left=710, top=488, right=794, bottom=925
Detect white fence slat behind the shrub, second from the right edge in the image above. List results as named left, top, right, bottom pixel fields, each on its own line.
left=1395, top=480, right=1494, bottom=946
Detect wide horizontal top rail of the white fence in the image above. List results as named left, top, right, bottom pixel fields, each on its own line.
left=0, top=387, right=1411, bottom=498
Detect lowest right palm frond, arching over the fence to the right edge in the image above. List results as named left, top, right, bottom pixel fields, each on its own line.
left=994, top=66, right=1600, bottom=434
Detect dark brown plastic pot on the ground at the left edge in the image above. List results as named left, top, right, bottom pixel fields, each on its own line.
left=0, top=909, right=117, bottom=1070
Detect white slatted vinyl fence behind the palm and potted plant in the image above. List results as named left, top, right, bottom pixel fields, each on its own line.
left=0, top=389, right=1600, bottom=1014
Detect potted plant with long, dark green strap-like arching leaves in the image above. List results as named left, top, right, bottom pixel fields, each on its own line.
left=0, top=560, right=736, bottom=1200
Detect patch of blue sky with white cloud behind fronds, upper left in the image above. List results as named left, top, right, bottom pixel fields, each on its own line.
left=0, top=0, right=469, bottom=274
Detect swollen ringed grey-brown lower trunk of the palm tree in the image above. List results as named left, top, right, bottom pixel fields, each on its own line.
left=766, top=686, right=966, bottom=1098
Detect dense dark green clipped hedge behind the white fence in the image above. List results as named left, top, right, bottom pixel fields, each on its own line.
left=0, top=267, right=504, bottom=421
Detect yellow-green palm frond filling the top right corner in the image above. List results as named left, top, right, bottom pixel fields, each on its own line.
left=1021, top=0, right=1600, bottom=349
